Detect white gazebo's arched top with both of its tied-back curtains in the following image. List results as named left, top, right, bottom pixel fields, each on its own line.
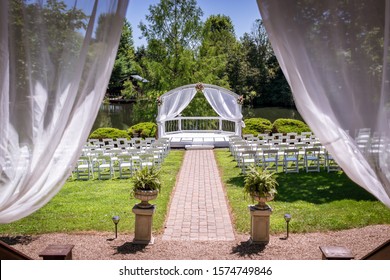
left=157, top=84, right=243, bottom=136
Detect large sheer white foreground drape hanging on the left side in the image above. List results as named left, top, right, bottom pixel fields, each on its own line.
left=0, top=0, right=128, bottom=223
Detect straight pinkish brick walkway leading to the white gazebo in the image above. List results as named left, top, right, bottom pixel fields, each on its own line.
left=163, top=150, right=234, bottom=241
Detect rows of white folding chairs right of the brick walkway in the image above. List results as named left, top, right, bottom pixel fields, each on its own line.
left=229, top=137, right=340, bottom=174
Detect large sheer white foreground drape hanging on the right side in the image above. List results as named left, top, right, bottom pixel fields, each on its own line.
left=257, top=0, right=390, bottom=207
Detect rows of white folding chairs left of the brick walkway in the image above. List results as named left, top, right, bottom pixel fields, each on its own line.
left=73, top=139, right=170, bottom=180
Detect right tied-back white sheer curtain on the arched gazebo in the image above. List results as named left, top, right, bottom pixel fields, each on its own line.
left=203, top=87, right=244, bottom=135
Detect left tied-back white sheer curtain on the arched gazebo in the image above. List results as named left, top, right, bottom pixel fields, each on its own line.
left=157, top=86, right=196, bottom=136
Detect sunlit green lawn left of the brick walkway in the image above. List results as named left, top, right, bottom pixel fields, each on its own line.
left=0, top=150, right=184, bottom=235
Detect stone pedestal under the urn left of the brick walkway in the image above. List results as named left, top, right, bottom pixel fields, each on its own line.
left=133, top=205, right=156, bottom=245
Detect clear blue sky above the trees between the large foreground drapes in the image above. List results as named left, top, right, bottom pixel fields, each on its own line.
left=126, top=0, right=260, bottom=47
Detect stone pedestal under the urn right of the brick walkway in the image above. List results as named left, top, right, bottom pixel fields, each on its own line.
left=248, top=205, right=272, bottom=245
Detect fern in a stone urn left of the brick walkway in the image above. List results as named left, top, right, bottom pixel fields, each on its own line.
left=132, top=166, right=161, bottom=208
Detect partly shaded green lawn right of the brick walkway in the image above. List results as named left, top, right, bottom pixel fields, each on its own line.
left=215, top=149, right=390, bottom=233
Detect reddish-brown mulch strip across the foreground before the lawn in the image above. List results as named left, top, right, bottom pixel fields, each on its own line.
left=0, top=225, right=390, bottom=260
